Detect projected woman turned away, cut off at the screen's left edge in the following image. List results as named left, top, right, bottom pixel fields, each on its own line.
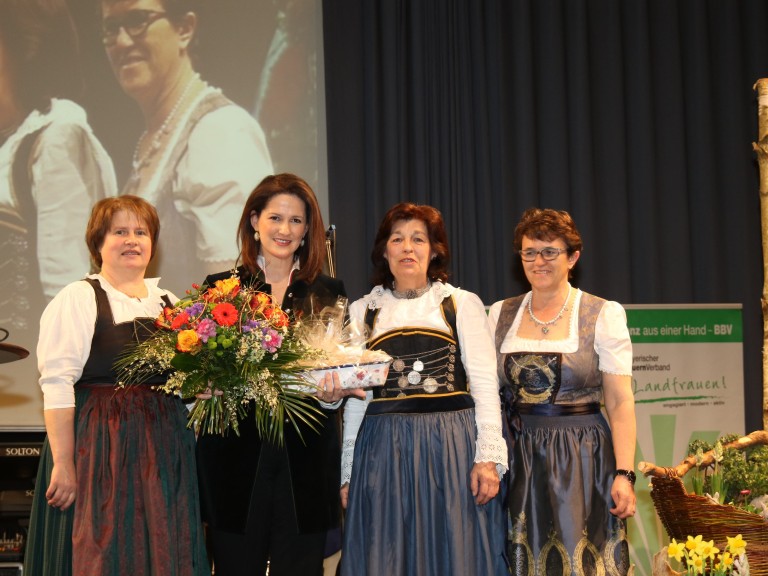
left=0, top=0, right=116, bottom=338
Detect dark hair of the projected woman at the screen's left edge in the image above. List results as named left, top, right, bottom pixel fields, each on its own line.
left=0, top=0, right=83, bottom=112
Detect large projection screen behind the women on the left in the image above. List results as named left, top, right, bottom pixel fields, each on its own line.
left=0, top=0, right=328, bottom=430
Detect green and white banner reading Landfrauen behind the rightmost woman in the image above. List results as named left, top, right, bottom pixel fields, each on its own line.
left=625, top=304, right=744, bottom=576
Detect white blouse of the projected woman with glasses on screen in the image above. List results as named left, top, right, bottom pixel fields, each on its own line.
left=130, top=87, right=273, bottom=290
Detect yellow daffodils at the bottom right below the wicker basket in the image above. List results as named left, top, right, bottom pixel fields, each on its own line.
left=667, top=534, right=749, bottom=576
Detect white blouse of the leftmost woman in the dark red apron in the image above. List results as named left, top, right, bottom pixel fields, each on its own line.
left=37, top=274, right=177, bottom=410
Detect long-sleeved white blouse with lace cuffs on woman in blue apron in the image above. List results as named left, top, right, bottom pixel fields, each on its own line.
left=341, top=282, right=507, bottom=484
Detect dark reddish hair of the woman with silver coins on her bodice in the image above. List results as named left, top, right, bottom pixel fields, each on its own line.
left=371, top=202, right=451, bottom=289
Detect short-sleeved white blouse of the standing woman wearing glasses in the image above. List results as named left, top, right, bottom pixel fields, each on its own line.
left=488, top=289, right=632, bottom=376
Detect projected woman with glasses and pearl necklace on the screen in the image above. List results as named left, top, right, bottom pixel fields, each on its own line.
left=102, top=0, right=272, bottom=291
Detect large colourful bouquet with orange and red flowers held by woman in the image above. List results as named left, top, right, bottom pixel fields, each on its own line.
left=115, top=276, right=321, bottom=443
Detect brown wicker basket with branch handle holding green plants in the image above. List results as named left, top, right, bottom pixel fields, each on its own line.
left=640, top=431, right=768, bottom=576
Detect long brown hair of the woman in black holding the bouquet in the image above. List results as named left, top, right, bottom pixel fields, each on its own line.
left=237, top=173, right=325, bottom=283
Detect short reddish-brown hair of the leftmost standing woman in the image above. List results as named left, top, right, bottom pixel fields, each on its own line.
left=85, top=194, right=160, bottom=268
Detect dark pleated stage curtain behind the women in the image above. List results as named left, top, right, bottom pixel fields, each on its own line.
left=323, top=0, right=768, bottom=431
